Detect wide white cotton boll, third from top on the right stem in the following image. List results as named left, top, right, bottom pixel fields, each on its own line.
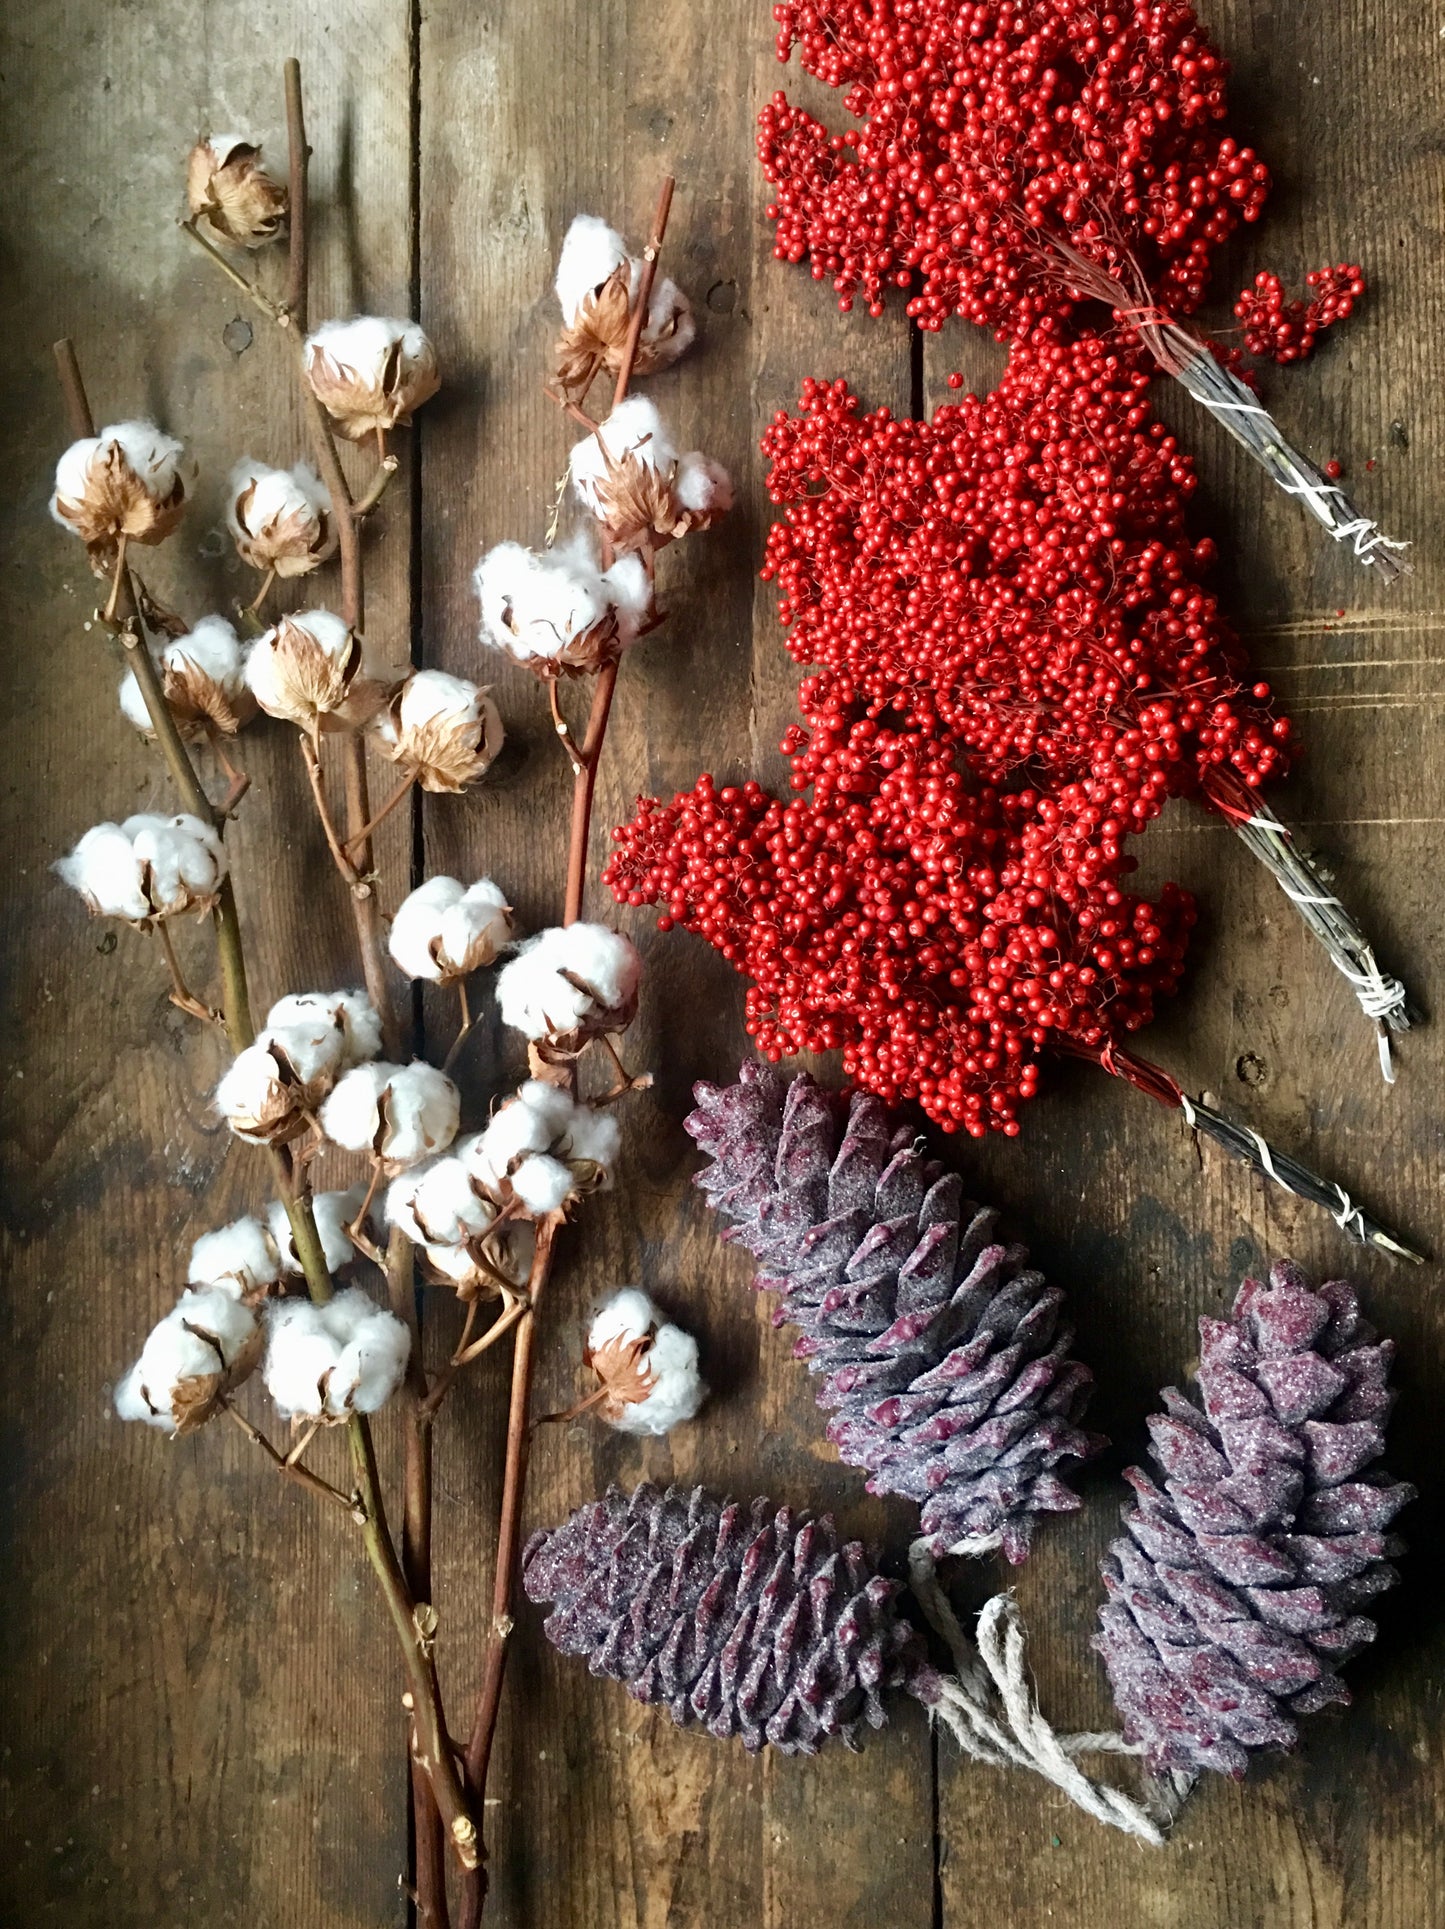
left=473, top=538, right=652, bottom=677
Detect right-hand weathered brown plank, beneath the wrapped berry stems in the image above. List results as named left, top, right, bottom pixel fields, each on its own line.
left=926, top=0, right=1445, bottom=1929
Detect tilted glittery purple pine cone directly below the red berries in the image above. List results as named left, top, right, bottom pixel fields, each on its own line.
left=687, top=1065, right=1104, bottom=1562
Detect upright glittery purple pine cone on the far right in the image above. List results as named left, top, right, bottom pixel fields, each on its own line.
left=1094, top=1265, right=1414, bottom=1777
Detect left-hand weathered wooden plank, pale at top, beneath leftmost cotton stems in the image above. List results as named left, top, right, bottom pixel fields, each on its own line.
left=0, top=0, right=409, bottom=1929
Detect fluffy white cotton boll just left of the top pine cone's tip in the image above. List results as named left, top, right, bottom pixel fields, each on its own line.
left=457, top=1078, right=619, bottom=1219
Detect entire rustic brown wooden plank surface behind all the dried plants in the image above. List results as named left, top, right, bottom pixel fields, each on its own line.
left=0, top=0, right=1445, bottom=1929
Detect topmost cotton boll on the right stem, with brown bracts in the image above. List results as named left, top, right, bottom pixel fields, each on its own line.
left=556, top=214, right=696, bottom=394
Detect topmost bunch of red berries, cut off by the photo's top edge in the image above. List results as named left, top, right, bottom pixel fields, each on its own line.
left=758, top=0, right=1269, bottom=340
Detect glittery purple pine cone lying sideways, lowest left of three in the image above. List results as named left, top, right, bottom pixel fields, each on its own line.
left=523, top=1483, right=938, bottom=1755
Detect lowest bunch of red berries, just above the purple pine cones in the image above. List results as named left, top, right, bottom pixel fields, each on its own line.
left=604, top=760, right=1194, bottom=1138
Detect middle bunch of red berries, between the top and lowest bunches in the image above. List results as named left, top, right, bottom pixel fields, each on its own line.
left=762, top=336, right=1289, bottom=852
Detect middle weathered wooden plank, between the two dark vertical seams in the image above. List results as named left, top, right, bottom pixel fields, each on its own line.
left=421, top=0, right=932, bottom=1929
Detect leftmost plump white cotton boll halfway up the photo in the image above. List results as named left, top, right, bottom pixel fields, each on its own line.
left=56, top=810, right=226, bottom=930
